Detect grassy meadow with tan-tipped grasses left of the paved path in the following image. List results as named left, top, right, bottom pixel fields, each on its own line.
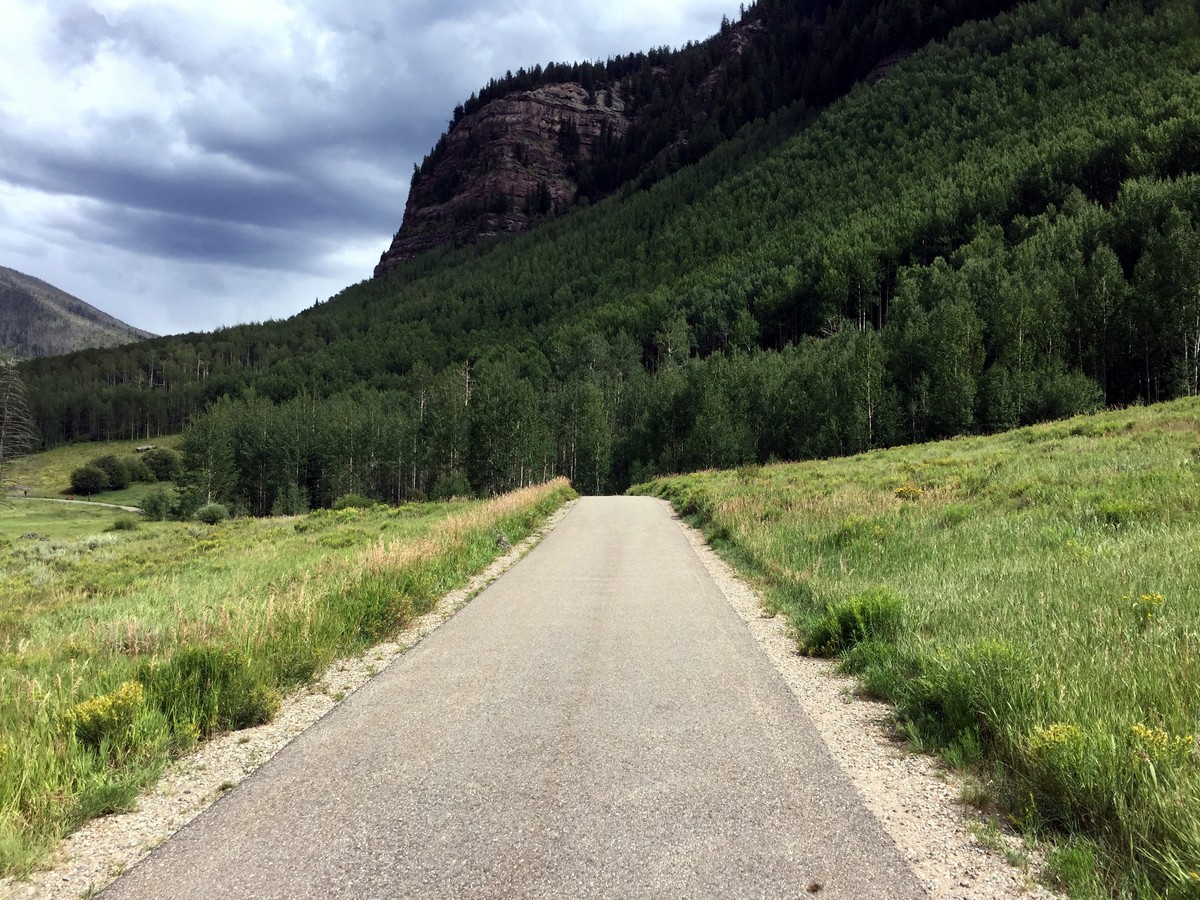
left=0, top=480, right=571, bottom=875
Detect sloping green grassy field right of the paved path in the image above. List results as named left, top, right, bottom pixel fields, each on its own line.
left=635, top=400, right=1200, bottom=898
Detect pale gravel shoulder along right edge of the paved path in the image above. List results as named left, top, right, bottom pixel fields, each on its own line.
left=679, top=508, right=1061, bottom=900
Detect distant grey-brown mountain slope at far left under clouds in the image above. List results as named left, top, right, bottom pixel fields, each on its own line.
left=0, top=266, right=154, bottom=356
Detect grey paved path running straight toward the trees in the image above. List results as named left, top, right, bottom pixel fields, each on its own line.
left=103, top=498, right=923, bottom=900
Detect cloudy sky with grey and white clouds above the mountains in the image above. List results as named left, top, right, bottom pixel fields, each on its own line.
left=0, top=0, right=737, bottom=334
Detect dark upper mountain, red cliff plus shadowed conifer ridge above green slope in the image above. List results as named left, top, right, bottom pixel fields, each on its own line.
left=374, top=0, right=1014, bottom=276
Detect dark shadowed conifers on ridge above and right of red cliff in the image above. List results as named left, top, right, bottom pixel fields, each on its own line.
left=414, top=0, right=1015, bottom=204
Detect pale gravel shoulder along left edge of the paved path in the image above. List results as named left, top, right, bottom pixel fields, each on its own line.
left=0, top=502, right=576, bottom=900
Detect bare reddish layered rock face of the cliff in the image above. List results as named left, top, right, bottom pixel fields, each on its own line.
left=374, top=83, right=630, bottom=276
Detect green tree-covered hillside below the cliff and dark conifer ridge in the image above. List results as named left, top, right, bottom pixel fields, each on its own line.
left=16, top=0, right=1200, bottom=512
